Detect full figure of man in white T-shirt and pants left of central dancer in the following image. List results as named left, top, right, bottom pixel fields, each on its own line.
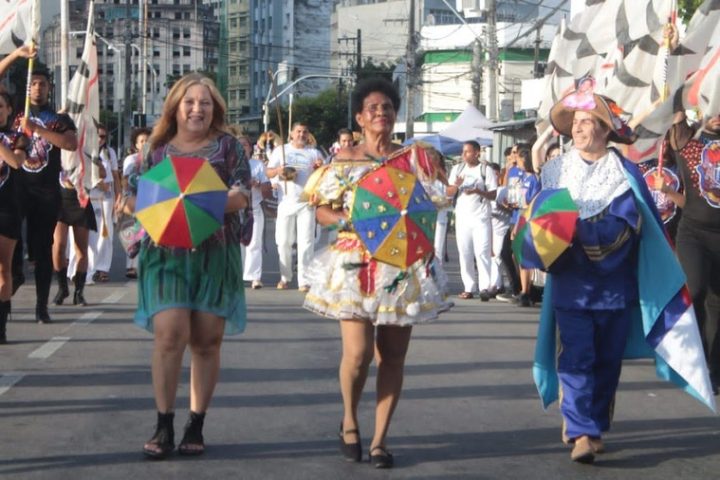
left=265, top=122, right=323, bottom=292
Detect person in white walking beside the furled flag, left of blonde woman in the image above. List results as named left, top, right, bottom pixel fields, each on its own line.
left=68, top=125, right=121, bottom=284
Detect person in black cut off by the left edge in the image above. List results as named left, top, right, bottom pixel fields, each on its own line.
left=0, top=92, right=30, bottom=344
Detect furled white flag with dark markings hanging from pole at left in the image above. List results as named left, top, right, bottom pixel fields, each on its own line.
left=62, top=2, right=101, bottom=206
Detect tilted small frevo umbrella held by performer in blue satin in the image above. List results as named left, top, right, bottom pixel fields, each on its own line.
left=512, top=188, right=578, bottom=270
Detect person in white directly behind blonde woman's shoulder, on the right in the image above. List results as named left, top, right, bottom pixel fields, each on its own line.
left=239, top=139, right=272, bottom=290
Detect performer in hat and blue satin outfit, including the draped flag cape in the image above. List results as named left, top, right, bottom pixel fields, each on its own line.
left=526, top=80, right=715, bottom=463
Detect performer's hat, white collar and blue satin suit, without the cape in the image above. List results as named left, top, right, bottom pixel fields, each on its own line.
left=542, top=85, right=647, bottom=463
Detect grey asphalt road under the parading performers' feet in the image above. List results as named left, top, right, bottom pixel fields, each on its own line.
left=0, top=223, right=720, bottom=480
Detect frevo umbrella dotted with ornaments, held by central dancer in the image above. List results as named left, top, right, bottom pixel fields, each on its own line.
left=350, top=165, right=437, bottom=270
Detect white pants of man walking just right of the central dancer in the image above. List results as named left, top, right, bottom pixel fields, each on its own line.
left=455, top=217, right=492, bottom=293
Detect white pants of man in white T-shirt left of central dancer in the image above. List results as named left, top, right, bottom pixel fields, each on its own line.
left=275, top=202, right=315, bottom=286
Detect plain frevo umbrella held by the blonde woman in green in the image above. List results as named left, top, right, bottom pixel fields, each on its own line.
left=135, top=155, right=227, bottom=248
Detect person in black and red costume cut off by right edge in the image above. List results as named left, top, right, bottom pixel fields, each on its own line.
left=670, top=111, right=720, bottom=395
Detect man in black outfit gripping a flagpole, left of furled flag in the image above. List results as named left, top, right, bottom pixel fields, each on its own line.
left=10, top=52, right=77, bottom=323
